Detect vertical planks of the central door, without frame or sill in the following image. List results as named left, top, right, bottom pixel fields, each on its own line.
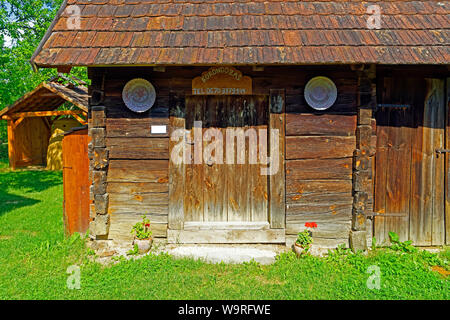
left=184, top=96, right=268, bottom=222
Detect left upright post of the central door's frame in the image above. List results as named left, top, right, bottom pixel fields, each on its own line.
left=168, top=92, right=186, bottom=230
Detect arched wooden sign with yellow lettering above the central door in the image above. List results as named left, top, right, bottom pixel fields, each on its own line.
left=192, top=67, right=253, bottom=96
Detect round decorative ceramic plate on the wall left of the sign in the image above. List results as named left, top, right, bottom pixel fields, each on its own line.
left=122, top=78, right=156, bottom=113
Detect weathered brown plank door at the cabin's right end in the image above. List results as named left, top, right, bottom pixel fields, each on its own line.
left=374, top=78, right=446, bottom=246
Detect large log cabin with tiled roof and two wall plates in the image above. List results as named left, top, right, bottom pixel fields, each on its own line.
left=32, top=0, right=450, bottom=250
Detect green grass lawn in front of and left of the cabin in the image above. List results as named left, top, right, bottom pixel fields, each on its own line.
left=0, top=145, right=450, bottom=300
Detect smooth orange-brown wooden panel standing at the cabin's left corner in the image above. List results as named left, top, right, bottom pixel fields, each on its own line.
left=63, top=129, right=91, bottom=235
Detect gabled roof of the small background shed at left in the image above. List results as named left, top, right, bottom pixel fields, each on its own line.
left=0, top=82, right=88, bottom=118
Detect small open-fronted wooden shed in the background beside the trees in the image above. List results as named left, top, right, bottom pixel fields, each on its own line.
left=0, top=75, right=88, bottom=170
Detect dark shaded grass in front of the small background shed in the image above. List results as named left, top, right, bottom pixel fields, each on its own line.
left=0, top=144, right=62, bottom=215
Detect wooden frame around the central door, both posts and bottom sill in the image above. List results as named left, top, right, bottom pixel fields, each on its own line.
left=167, top=89, right=286, bottom=244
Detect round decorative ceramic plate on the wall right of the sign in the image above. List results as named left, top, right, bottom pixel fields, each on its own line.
left=305, top=77, right=337, bottom=110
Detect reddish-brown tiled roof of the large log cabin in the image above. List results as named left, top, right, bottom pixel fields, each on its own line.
left=32, top=0, right=450, bottom=67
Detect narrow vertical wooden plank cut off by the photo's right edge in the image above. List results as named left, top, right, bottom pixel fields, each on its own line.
left=445, top=78, right=450, bottom=245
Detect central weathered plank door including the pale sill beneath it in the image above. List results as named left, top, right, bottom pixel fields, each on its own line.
left=169, top=95, right=284, bottom=243
